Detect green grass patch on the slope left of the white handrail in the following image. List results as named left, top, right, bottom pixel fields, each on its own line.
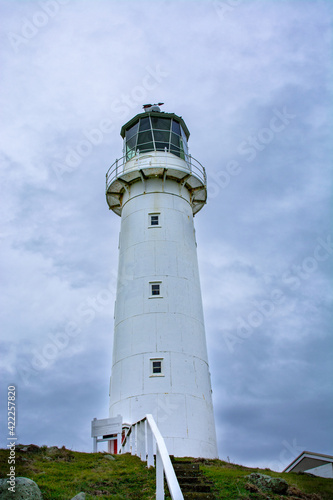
left=0, top=447, right=155, bottom=500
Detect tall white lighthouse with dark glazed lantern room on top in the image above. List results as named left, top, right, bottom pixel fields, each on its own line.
left=106, top=103, right=218, bottom=458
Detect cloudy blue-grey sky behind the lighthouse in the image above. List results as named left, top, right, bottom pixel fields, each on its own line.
left=0, top=0, right=333, bottom=470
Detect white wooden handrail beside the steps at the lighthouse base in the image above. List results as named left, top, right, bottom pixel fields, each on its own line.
left=119, top=414, right=184, bottom=500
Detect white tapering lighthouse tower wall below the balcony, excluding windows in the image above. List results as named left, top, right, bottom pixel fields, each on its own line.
left=110, top=155, right=218, bottom=458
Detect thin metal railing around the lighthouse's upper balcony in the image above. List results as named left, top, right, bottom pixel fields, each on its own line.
left=106, top=151, right=207, bottom=192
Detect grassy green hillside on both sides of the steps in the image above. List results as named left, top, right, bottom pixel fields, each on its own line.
left=0, top=445, right=333, bottom=500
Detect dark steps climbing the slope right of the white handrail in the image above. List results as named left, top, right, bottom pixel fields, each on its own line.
left=170, top=457, right=216, bottom=500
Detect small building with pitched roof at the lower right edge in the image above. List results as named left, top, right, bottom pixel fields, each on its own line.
left=283, top=451, right=333, bottom=478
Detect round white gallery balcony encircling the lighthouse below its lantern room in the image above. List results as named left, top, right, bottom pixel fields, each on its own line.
left=106, top=150, right=207, bottom=215
